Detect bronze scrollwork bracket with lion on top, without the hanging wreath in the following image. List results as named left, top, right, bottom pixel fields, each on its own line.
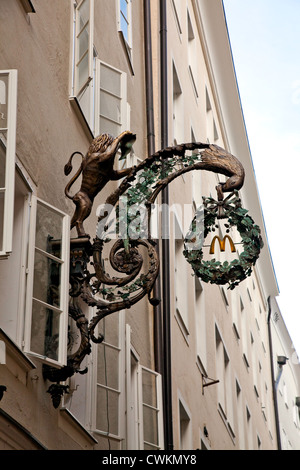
left=45, top=131, right=259, bottom=404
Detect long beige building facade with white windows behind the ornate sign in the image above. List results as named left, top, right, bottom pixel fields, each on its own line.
left=0, top=0, right=299, bottom=450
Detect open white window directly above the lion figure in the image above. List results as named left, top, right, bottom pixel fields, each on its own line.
left=70, top=0, right=131, bottom=137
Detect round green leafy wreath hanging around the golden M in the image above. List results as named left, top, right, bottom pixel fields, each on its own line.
left=183, top=191, right=263, bottom=290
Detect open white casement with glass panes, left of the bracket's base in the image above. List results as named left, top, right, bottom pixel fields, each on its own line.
left=25, top=196, right=70, bottom=365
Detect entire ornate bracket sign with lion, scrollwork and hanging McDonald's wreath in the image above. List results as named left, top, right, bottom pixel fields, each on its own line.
left=44, top=131, right=262, bottom=407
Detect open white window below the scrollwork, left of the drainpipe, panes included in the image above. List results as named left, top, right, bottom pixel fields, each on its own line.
left=93, top=322, right=163, bottom=450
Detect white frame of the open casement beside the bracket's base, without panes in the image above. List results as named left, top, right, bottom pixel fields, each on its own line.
left=24, top=194, right=70, bottom=367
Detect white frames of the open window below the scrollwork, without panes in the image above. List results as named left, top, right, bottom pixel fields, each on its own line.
left=89, top=322, right=164, bottom=450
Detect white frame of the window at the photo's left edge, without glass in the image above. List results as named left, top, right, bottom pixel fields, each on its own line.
left=0, top=69, right=18, bottom=259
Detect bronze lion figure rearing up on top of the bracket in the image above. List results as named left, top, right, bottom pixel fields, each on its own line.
left=64, top=131, right=136, bottom=237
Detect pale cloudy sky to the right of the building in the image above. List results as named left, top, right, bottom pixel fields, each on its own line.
left=224, top=0, right=300, bottom=356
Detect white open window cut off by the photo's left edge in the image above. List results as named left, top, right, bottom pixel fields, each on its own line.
left=0, top=70, right=17, bottom=257
